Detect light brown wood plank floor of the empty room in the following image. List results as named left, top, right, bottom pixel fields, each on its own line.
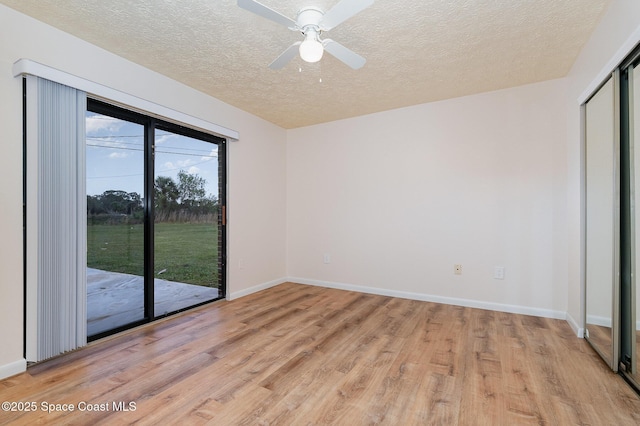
left=0, top=283, right=640, bottom=425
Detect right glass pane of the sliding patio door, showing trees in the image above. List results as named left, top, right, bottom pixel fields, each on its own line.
left=153, top=128, right=222, bottom=317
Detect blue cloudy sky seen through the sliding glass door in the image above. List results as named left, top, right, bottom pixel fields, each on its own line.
left=86, top=111, right=218, bottom=197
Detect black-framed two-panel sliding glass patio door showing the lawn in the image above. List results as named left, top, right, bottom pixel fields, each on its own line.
left=86, top=100, right=225, bottom=340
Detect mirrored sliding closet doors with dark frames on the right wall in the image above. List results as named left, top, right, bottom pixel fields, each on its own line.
left=582, top=47, right=640, bottom=392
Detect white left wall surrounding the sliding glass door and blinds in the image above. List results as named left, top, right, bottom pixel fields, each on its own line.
left=0, top=5, right=286, bottom=378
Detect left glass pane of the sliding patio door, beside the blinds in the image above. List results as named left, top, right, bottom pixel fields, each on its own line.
left=86, top=111, right=144, bottom=337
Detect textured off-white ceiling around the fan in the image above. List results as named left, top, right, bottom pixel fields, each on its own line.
left=0, top=0, right=611, bottom=128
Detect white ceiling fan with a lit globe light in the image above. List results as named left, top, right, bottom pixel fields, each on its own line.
left=238, top=0, right=374, bottom=70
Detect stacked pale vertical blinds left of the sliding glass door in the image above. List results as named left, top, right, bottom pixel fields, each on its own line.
left=26, top=76, right=87, bottom=361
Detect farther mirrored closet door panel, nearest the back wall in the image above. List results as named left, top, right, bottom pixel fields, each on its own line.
left=585, top=78, right=619, bottom=370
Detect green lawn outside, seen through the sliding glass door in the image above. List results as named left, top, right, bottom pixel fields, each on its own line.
left=87, top=223, right=218, bottom=287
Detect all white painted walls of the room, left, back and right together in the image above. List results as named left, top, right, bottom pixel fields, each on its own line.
left=5, top=0, right=640, bottom=377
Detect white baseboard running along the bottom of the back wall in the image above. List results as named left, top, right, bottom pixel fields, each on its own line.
left=286, top=277, right=567, bottom=320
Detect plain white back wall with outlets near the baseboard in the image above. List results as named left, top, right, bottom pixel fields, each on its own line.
left=287, top=79, right=567, bottom=317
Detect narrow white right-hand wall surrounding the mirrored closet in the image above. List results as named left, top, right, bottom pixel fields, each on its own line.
left=566, top=0, right=640, bottom=331
